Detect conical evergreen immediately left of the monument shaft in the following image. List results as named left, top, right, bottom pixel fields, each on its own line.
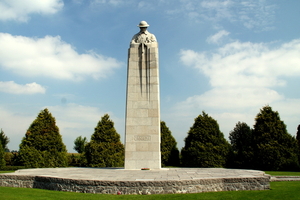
left=84, top=114, right=124, bottom=167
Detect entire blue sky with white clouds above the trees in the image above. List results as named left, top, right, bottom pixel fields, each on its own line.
left=0, top=0, right=300, bottom=152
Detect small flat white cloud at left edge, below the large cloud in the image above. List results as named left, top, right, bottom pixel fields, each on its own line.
left=0, top=81, right=46, bottom=94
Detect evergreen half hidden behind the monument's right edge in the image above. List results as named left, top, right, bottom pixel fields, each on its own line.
left=160, top=121, right=179, bottom=166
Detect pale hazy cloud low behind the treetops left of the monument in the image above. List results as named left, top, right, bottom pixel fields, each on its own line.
left=0, top=103, right=125, bottom=152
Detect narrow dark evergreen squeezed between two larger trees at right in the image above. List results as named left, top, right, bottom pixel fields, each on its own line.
left=229, top=122, right=253, bottom=169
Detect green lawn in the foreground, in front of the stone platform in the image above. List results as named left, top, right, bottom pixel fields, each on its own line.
left=0, top=181, right=300, bottom=200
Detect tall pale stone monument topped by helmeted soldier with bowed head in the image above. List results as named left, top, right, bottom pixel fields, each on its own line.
left=125, top=21, right=161, bottom=169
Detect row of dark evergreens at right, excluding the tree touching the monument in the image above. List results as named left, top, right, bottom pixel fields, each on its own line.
left=181, top=106, right=300, bottom=170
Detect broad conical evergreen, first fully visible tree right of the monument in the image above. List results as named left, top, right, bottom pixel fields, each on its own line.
left=181, top=112, right=230, bottom=167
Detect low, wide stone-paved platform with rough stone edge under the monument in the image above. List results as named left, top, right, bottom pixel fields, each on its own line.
left=0, top=168, right=270, bottom=194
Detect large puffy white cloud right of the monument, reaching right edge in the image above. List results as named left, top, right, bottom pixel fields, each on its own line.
left=181, top=40, right=300, bottom=87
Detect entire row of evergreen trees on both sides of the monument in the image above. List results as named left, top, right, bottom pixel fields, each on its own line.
left=0, top=106, right=300, bottom=170
